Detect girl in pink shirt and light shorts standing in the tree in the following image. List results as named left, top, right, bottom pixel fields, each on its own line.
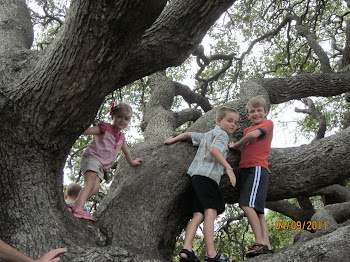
left=68, top=103, right=143, bottom=220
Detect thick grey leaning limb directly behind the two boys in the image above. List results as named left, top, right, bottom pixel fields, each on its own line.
left=97, top=75, right=350, bottom=259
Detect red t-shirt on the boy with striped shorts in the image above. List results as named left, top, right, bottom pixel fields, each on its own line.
left=239, top=120, right=273, bottom=173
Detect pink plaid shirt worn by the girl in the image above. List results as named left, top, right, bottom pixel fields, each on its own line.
left=83, top=121, right=125, bottom=170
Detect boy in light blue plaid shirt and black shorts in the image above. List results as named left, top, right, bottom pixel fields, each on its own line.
left=164, top=107, right=239, bottom=262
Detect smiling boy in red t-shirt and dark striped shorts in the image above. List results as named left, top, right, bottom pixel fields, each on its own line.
left=229, top=96, right=273, bottom=257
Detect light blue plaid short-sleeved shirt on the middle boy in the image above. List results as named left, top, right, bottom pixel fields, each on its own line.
left=187, top=125, right=229, bottom=184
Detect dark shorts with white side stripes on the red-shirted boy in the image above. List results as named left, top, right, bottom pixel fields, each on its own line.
left=239, top=166, right=269, bottom=214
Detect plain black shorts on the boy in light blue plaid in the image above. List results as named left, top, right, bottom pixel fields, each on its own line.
left=187, top=175, right=225, bottom=215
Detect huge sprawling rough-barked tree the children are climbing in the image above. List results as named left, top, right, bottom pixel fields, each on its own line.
left=0, top=0, right=350, bottom=261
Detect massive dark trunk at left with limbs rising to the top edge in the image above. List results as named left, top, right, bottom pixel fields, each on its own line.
left=0, top=0, right=234, bottom=262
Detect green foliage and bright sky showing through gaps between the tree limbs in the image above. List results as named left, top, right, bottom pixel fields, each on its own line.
left=27, top=0, right=350, bottom=261
